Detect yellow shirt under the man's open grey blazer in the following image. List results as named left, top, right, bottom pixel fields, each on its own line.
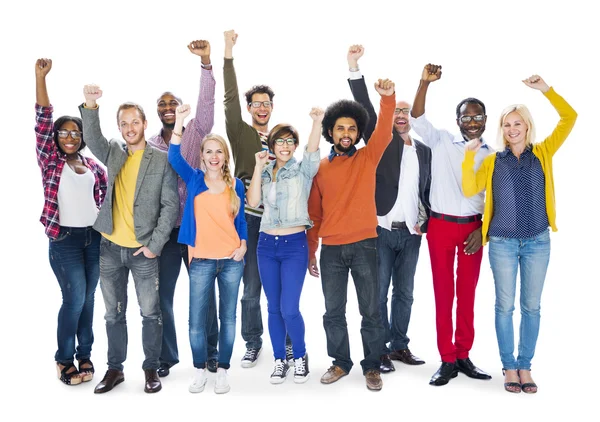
left=102, top=149, right=144, bottom=248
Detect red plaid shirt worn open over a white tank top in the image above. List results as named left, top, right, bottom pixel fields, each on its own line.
left=35, top=104, right=107, bottom=239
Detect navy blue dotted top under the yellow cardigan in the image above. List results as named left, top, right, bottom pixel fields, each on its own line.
left=488, top=147, right=549, bottom=239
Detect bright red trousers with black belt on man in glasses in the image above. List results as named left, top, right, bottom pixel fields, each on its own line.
left=427, top=217, right=483, bottom=362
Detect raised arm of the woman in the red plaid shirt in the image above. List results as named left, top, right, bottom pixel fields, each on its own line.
left=35, top=59, right=56, bottom=167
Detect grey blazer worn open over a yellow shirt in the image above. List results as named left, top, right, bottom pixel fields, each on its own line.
left=79, top=104, right=179, bottom=255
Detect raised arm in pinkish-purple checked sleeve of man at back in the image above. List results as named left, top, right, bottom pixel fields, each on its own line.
left=181, top=40, right=215, bottom=168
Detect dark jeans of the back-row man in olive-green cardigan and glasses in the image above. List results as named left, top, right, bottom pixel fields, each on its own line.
left=241, top=213, right=263, bottom=349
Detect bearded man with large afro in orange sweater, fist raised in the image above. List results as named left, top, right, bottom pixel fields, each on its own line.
left=307, top=79, right=396, bottom=391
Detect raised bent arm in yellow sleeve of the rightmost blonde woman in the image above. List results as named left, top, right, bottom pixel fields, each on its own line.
left=523, top=75, right=577, bottom=156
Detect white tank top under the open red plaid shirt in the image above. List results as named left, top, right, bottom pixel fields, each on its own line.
left=58, top=163, right=98, bottom=227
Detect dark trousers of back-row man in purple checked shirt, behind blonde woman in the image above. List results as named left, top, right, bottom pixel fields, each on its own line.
left=158, top=227, right=219, bottom=368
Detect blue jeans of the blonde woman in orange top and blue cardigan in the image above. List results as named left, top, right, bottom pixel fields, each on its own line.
left=189, top=258, right=244, bottom=369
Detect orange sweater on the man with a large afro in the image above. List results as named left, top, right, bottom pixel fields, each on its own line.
left=307, top=94, right=396, bottom=259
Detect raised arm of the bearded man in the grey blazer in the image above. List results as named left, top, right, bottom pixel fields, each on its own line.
left=79, top=85, right=110, bottom=165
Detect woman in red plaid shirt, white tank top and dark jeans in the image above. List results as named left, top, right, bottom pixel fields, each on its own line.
left=35, top=59, right=106, bottom=385
